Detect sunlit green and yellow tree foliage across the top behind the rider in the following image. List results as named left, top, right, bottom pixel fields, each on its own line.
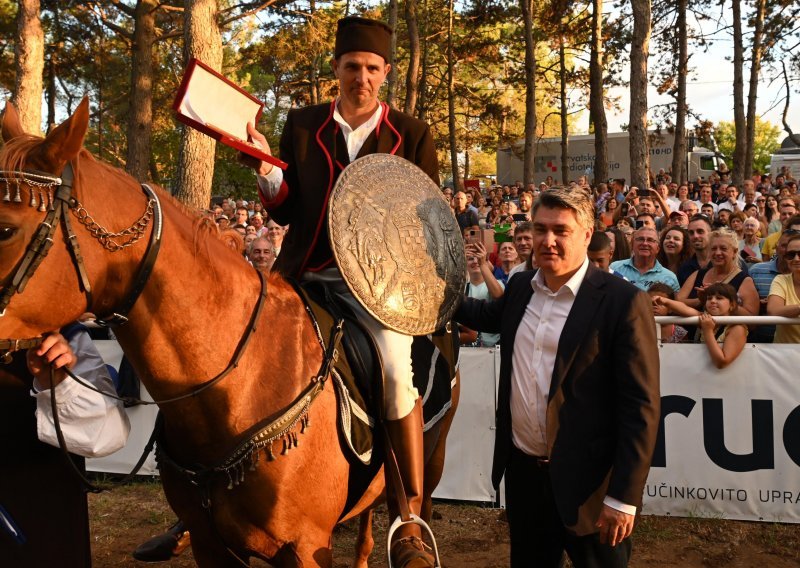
left=10, top=0, right=800, bottom=197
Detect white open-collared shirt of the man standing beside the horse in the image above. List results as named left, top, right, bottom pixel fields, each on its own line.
left=511, top=258, right=636, bottom=515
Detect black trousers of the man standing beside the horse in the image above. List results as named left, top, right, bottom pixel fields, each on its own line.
left=506, top=447, right=631, bottom=568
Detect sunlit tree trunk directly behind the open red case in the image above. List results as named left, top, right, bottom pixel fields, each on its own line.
left=175, top=0, right=222, bottom=209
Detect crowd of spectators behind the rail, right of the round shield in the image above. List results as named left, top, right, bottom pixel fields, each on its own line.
left=450, top=171, right=800, bottom=367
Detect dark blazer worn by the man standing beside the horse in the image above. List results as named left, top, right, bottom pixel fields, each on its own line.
left=455, top=265, right=660, bottom=535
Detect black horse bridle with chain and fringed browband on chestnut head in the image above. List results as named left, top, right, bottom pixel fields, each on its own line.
left=0, top=163, right=162, bottom=363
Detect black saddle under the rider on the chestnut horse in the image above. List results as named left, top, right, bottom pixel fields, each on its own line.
left=293, top=281, right=383, bottom=464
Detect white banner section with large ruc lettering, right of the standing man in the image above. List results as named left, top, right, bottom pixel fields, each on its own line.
left=643, top=344, right=800, bottom=523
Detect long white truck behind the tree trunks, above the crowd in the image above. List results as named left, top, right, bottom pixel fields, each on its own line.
left=497, top=130, right=722, bottom=185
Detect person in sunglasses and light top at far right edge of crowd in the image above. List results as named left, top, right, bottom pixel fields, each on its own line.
left=767, top=229, right=800, bottom=343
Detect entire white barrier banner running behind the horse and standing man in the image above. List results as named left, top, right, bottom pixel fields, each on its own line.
left=87, top=342, right=800, bottom=523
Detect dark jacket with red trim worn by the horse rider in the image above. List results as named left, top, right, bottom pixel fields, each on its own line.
left=263, top=102, right=439, bottom=277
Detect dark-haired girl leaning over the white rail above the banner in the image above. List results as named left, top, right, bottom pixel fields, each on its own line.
left=653, top=282, right=747, bottom=369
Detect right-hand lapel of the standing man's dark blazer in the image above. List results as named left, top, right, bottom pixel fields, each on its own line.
left=548, top=265, right=603, bottom=401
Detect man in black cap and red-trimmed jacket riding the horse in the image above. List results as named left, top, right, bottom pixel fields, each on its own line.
left=240, top=17, right=439, bottom=566
